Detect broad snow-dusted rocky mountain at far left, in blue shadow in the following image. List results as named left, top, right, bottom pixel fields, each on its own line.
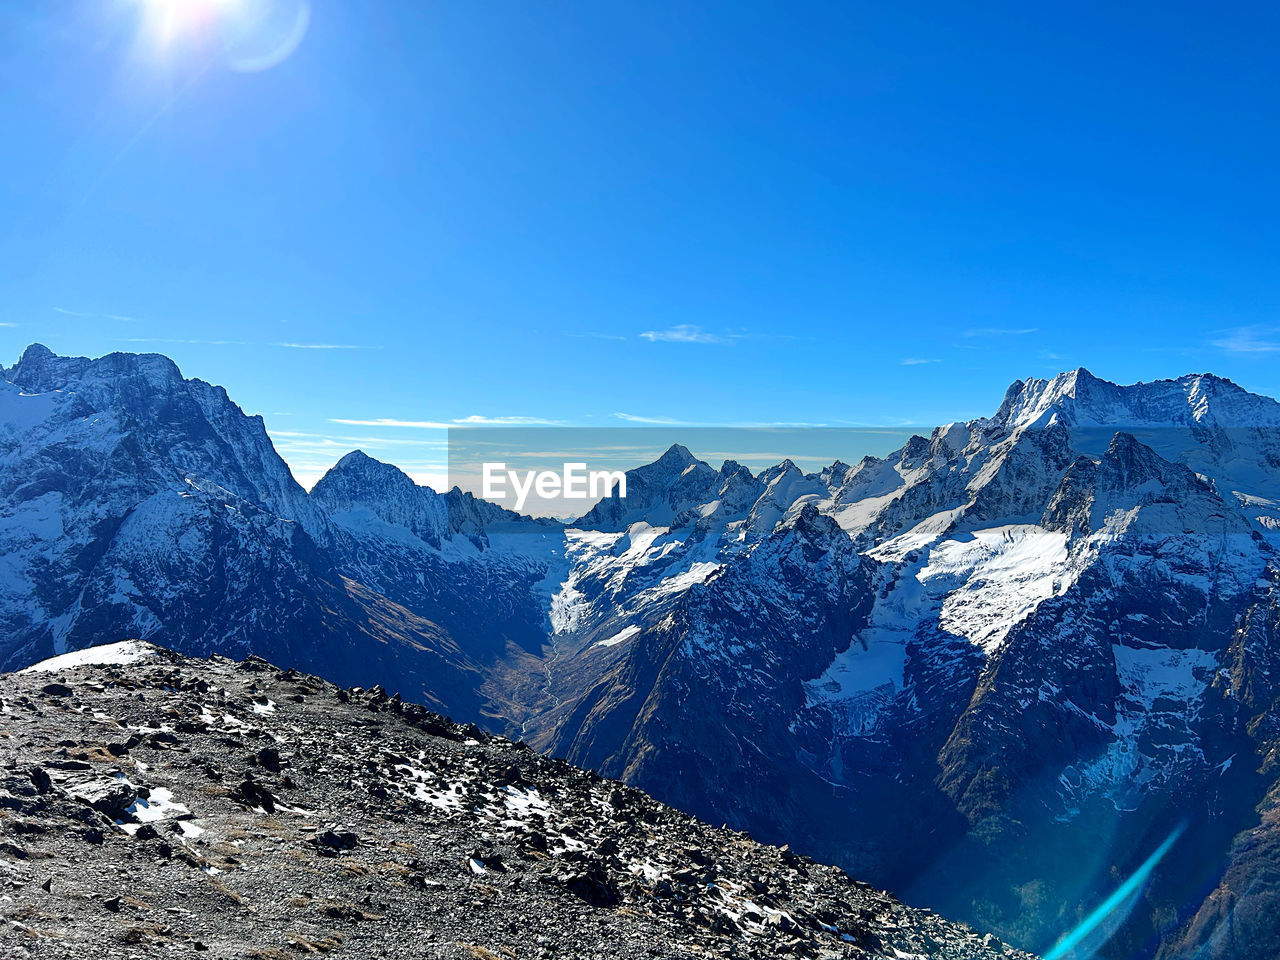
left=0, top=344, right=476, bottom=721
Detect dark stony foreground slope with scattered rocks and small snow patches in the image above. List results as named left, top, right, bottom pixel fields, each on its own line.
left=0, top=643, right=1025, bottom=960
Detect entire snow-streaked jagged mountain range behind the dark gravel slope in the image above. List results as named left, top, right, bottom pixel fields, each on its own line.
left=0, top=344, right=1280, bottom=959
